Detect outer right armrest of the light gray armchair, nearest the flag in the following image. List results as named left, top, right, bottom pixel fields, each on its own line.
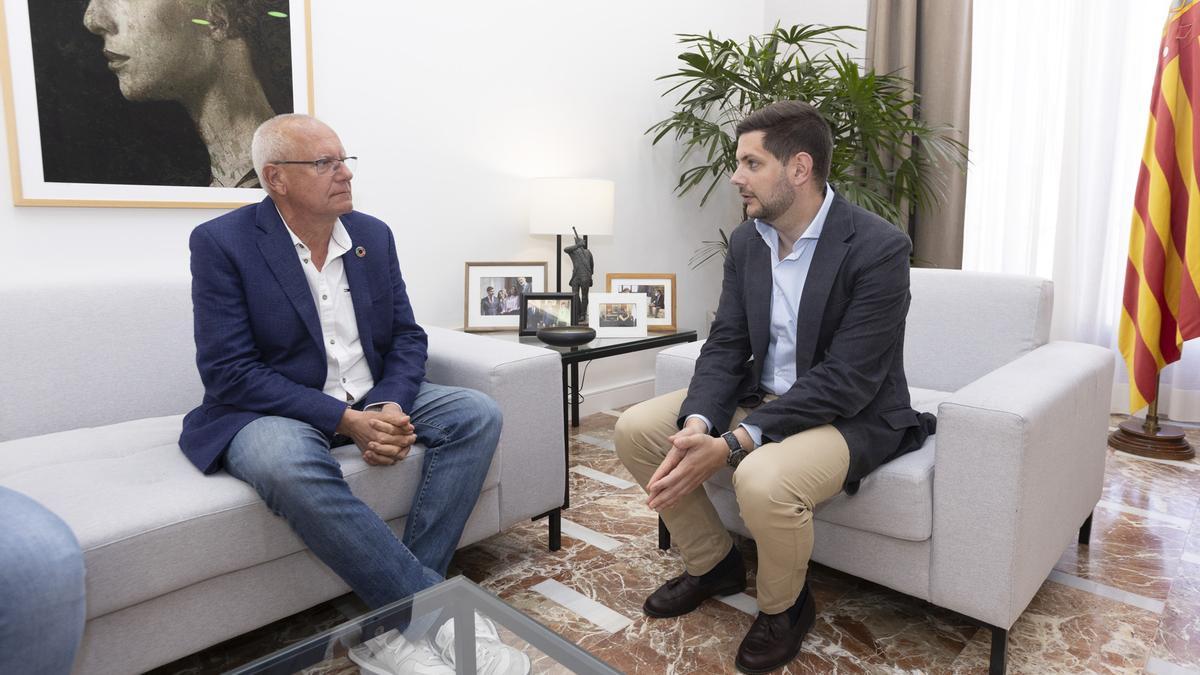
left=930, top=342, right=1114, bottom=629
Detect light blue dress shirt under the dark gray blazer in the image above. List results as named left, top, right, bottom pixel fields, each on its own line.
left=688, top=184, right=833, bottom=448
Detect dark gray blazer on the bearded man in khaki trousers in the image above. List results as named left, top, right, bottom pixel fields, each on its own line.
left=678, top=195, right=936, bottom=494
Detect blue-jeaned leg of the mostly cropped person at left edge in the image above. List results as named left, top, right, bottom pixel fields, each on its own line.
left=0, top=488, right=86, bottom=674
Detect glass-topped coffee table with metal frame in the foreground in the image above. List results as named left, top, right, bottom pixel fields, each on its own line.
left=232, top=577, right=619, bottom=675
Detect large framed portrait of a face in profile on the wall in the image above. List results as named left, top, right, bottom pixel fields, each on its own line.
left=0, top=0, right=313, bottom=208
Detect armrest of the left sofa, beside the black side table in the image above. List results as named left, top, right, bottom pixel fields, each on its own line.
left=426, top=327, right=566, bottom=527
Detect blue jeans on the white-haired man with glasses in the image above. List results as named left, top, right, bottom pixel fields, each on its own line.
left=224, top=382, right=500, bottom=608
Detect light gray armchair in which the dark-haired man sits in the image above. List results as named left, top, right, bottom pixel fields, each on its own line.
left=655, top=269, right=1114, bottom=673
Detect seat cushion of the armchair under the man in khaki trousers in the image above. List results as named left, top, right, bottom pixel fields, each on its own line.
left=709, top=388, right=950, bottom=542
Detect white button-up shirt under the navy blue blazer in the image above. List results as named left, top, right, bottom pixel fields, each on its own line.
left=280, top=214, right=374, bottom=404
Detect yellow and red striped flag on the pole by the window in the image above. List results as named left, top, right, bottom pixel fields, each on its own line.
left=1118, top=0, right=1200, bottom=412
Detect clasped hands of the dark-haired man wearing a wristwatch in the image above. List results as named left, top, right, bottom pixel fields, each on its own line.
left=646, top=418, right=730, bottom=512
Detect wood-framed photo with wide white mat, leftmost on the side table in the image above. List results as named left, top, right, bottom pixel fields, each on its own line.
left=462, top=258, right=546, bottom=333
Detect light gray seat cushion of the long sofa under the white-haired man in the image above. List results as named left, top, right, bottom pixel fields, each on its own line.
left=0, top=416, right=499, bottom=619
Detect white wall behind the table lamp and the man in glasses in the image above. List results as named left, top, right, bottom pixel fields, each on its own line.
left=0, top=0, right=763, bottom=405
